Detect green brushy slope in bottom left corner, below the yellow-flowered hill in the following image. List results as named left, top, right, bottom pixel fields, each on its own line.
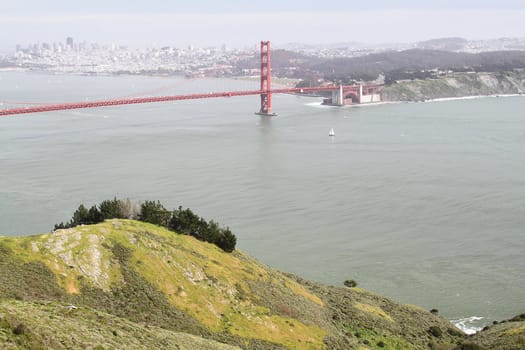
left=0, top=300, right=235, bottom=350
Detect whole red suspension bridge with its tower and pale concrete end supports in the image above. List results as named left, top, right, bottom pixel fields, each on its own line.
left=0, top=41, right=382, bottom=116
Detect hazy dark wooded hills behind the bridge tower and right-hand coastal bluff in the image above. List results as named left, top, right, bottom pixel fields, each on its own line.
left=238, top=45, right=525, bottom=84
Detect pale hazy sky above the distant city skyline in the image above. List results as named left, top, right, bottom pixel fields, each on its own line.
left=0, top=0, right=525, bottom=48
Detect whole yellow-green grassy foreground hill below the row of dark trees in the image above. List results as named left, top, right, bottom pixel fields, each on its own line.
left=0, top=220, right=516, bottom=349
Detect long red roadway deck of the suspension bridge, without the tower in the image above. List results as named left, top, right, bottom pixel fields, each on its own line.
left=0, top=85, right=344, bottom=116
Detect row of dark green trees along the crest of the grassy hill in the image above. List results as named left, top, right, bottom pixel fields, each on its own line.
left=55, top=198, right=237, bottom=252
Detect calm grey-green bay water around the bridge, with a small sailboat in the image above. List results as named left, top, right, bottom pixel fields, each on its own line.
left=0, top=72, right=525, bottom=329
